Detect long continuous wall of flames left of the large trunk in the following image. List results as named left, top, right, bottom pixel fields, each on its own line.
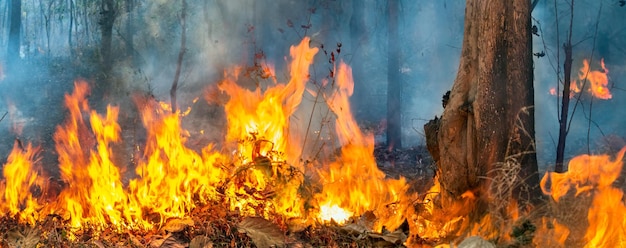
left=0, top=37, right=411, bottom=236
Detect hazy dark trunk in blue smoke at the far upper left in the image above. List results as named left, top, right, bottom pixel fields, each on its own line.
left=6, top=0, right=22, bottom=69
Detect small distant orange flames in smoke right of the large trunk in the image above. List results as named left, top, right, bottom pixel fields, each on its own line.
left=550, top=59, right=613, bottom=100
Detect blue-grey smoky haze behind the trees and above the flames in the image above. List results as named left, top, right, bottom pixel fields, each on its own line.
left=0, top=0, right=626, bottom=168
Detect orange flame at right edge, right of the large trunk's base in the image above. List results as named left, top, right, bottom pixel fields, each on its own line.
left=541, top=147, right=626, bottom=247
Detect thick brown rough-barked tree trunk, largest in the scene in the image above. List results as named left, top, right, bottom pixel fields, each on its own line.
left=435, top=0, right=540, bottom=207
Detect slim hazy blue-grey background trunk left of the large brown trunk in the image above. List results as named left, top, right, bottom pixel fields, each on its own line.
left=387, top=0, right=402, bottom=148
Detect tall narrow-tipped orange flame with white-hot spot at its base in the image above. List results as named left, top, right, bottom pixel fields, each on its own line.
left=315, top=62, right=408, bottom=231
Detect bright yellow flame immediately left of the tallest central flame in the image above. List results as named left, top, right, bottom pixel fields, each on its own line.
left=129, top=99, right=225, bottom=223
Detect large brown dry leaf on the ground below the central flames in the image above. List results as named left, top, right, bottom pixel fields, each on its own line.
left=237, top=217, right=285, bottom=248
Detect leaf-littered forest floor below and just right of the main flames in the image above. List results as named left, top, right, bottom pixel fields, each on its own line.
left=0, top=147, right=433, bottom=248
